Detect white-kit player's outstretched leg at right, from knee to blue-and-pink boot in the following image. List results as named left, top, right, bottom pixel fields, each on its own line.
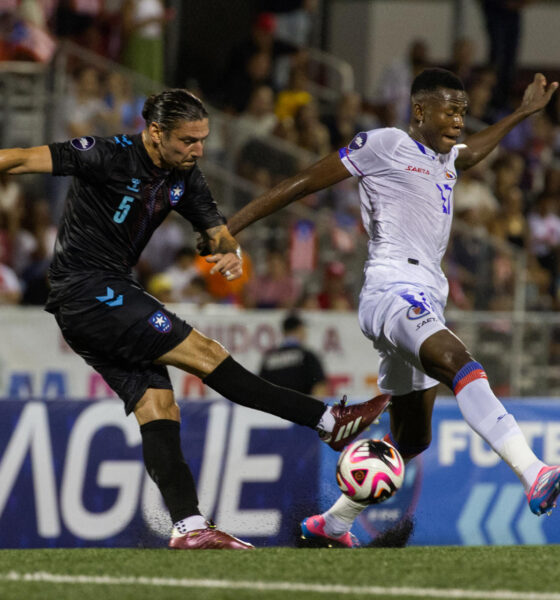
left=419, top=330, right=560, bottom=515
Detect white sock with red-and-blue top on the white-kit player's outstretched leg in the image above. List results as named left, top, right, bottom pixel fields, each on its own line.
left=454, top=363, right=545, bottom=492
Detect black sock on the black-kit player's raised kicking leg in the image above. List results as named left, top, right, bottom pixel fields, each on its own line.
left=202, top=356, right=326, bottom=428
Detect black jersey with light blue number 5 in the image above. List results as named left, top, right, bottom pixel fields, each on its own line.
left=47, top=134, right=226, bottom=309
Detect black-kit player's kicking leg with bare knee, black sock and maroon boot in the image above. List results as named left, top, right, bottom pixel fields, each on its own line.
left=157, top=330, right=389, bottom=450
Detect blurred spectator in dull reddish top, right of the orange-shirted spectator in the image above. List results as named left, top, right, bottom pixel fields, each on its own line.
left=245, top=250, right=301, bottom=308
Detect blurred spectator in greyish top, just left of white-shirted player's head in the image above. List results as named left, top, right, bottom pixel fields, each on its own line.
left=374, top=39, right=430, bottom=129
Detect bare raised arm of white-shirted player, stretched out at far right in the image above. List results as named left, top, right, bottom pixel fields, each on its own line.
left=455, top=73, right=558, bottom=169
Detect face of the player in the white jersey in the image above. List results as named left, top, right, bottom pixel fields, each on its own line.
left=414, top=89, right=467, bottom=154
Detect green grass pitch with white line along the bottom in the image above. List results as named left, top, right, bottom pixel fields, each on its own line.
left=0, top=546, right=560, bottom=600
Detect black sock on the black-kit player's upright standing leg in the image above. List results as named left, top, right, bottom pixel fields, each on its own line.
left=140, top=419, right=200, bottom=523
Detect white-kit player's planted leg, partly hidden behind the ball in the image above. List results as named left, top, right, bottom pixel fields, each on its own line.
left=302, top=386, right=436, bottom=548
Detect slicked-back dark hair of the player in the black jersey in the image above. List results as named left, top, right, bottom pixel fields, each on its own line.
left=142, top=88, right=208, bottom=131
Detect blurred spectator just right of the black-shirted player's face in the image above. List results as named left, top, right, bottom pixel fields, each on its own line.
left=231, top=85, right=278, bottom=155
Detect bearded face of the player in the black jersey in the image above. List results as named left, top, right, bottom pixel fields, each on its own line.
left=158, top=119, right=210, bottom=170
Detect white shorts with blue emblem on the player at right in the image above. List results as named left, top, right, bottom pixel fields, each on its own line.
left=358, top=283, right=447, bottom=396
